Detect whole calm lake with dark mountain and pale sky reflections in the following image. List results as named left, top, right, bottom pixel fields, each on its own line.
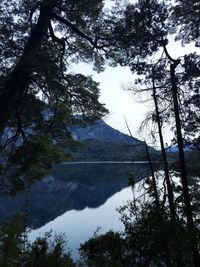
left=0, top=162, right=148, bottom=259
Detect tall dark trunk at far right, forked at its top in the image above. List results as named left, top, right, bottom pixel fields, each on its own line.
left=170, top=60, right=200, bottom=267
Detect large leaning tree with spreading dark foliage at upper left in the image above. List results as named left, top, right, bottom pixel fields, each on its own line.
left=0, top=0, right=111, bottom=142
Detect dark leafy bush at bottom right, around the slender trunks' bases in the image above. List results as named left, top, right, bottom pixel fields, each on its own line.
left=119, top=198, right=192, bottom=266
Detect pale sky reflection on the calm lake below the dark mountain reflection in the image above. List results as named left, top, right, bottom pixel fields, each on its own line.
left=30, top=188, right=133, bottom=259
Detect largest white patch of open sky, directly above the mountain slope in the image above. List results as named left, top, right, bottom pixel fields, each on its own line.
left=73, top=64, right=145, bottom=138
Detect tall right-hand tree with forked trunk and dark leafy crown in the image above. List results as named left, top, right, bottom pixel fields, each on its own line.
left=107, top=0, right=200, bottom=266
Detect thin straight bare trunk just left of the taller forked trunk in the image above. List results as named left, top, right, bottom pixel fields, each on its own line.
left=153, top=77, right=176, bottom=220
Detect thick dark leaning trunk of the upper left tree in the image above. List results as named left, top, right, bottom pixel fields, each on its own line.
left=0, top=1, right=55, bottom=136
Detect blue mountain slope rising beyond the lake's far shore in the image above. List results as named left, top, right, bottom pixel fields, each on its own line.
left=71, top=120, right=157, bottom=161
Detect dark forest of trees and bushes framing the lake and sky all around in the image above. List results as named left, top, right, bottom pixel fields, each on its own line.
left=0, top=0, right=200, bottom=267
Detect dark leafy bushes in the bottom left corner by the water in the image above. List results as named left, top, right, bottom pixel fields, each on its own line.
left=0, top=216, right=75, bottom=267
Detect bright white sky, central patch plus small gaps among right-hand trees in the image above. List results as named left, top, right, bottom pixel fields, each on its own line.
left=71, top=38, right=200, bottom=148
